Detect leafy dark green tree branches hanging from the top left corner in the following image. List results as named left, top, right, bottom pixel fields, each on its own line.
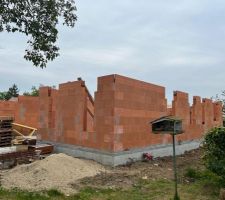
left=0, top=0, right=77, bottom=68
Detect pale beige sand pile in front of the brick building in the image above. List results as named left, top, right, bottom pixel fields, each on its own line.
left=2, top=154, right=105, bottom=193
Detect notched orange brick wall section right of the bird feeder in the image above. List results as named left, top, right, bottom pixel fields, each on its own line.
left=172, top=91, right=222, bottom=141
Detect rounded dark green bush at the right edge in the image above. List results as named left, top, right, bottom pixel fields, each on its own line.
left=203, top=127, right=225, bottom=183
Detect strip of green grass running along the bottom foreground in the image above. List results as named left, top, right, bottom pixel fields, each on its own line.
left=0, top=169, right=222, bottom=200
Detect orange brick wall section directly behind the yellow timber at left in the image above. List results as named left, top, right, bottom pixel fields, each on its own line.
left=15, top=96, right=40, bottom=128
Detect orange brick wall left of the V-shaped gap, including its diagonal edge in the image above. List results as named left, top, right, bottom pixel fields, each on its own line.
left=39, top=81, right=95, bottom=147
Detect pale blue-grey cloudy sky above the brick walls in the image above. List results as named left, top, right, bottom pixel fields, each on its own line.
left=0, top=0, right=225, bottom=101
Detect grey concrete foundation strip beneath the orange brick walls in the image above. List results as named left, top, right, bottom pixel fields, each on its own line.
left=38, top=140, right=201, bottom=167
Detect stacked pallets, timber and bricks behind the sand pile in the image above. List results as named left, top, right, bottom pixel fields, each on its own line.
left=0, top=117, right=53, bottom=169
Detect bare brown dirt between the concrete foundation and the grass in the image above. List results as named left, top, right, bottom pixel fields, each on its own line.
left=72, top=149, right=203, bottom=190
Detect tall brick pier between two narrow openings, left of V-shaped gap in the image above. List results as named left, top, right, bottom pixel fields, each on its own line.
left=56, top=82, right=86, bottom=144
